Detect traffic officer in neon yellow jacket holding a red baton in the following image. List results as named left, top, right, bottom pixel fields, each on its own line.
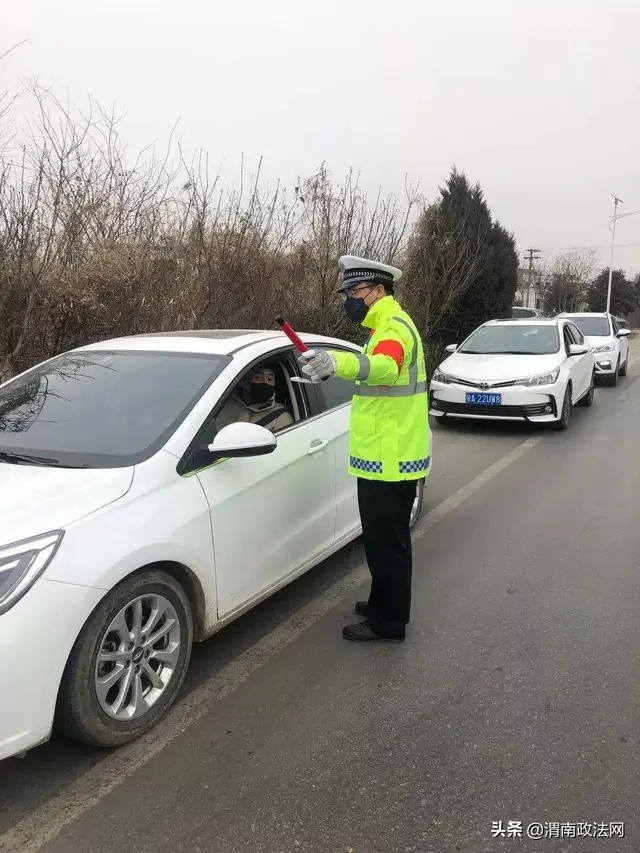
left=300, top=255, right=430, bottom=641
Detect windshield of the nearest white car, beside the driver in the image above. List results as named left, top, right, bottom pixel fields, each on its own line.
left=0, top=351, right=229, bottom=468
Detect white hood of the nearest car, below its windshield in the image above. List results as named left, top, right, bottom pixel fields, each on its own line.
left=0, top=462, right=134, bottom=545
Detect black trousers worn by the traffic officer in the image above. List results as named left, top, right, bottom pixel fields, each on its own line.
left=358, top=478, right=416, bottom=636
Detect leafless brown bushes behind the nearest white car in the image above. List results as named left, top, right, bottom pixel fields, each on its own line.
left=0, top=83, right=418, bottom=380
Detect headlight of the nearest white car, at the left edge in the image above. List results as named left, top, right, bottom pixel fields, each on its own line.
left=0, top=530, right=64, bottom=616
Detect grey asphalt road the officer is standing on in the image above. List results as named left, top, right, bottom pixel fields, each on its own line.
left=0, top=362, right=640, bottom=853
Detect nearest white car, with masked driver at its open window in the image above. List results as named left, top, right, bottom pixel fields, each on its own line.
left=0, top=331, right=424, bottom=758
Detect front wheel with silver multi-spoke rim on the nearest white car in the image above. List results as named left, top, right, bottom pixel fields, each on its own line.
left=56, top=571, right=193, bottom=747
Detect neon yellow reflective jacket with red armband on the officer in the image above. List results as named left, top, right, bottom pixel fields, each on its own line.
left=332, top=296, right=430, bottom=481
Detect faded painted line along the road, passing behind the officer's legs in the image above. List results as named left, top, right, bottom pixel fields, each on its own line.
left=0, top=432, right=568, bottom=853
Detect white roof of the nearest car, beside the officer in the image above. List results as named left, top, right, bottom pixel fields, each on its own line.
left=75, top=329, right=348, bottom=356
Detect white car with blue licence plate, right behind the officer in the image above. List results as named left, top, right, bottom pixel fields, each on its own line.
left=429, top=317, right=595, bottom=430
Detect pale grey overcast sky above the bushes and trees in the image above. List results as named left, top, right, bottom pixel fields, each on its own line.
left=5, top=0, right=640, bottom=273
